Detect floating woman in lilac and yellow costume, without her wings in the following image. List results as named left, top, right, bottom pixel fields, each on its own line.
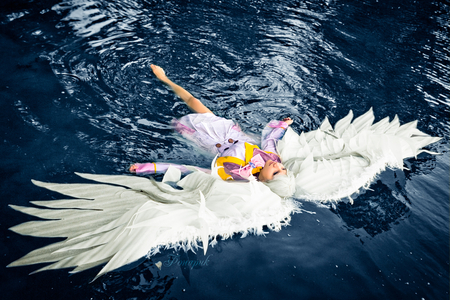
left=130, top=65, right=295, bottom=197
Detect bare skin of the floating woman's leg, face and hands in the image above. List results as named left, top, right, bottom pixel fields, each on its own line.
left=130, top=65, right=294, bottom=182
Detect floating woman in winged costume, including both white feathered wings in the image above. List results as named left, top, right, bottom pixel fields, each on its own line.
left=9, top=65, right=439, bottom=277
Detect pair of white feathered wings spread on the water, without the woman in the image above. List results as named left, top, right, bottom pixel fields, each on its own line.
left=9, top=110, right=439, bottom=276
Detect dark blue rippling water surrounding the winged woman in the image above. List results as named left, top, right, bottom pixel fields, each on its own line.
left=0, top=0, right=450, bottom=299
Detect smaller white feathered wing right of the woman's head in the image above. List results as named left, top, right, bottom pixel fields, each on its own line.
left=278, top=109, right=441, bottom=202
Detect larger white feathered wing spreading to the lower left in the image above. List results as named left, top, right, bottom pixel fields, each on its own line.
left=9, top=170, right=299, bottom=278
